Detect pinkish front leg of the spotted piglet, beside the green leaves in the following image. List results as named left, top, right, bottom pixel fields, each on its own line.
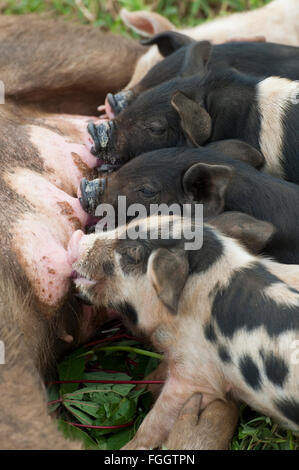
left=123, top=377, right=197, bottom=450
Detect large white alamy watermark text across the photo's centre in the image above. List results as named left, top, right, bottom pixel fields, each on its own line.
left=95, top=196, right=203, bottom=250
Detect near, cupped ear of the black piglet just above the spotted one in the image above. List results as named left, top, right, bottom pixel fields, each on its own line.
left=183, top=163, right=234, bottom=217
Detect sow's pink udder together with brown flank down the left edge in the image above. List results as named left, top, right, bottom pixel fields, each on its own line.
left=0, top=102, right=100, bottom=449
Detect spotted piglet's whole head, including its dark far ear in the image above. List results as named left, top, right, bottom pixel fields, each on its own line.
left=69, top=213, right=274, bottom=338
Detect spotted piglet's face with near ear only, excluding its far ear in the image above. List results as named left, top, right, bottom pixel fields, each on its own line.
left=69, top=216, right=189, bottom=334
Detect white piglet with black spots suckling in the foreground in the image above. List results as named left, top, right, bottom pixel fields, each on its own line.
left=69, top=216, right=299, bottom=449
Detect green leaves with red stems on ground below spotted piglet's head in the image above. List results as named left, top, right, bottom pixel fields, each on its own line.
left=49, top=340, right=160, bottom=450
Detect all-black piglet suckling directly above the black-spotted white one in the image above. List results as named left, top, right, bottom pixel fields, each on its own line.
left=81, top=140, right=299, bottom=264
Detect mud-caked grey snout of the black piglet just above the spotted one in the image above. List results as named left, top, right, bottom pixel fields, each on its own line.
left=79, top=178, right=106, bottom=215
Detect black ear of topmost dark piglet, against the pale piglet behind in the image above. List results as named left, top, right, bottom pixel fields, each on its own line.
left=141, top=31, right=194, bottom=57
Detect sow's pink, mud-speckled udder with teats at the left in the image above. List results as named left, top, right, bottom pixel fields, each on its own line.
left=1, top=108, right=102, bottom=310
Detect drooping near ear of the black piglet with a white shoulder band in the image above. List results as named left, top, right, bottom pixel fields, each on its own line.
left=171, top=91, right=212, bottom=147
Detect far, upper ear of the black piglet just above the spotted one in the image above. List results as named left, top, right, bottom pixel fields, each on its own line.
left=207, top=139, right=265, bottom=169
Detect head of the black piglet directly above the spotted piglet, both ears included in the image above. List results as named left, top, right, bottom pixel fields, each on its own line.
left=82, top=140, right=264, bottom=219
